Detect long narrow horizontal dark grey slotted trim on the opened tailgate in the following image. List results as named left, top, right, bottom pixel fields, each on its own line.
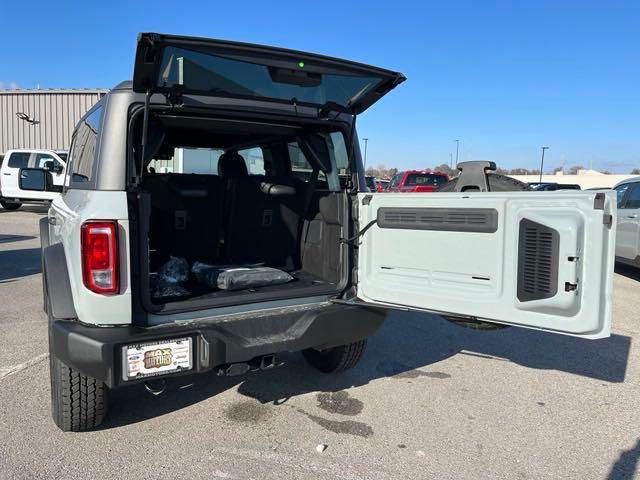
left=378, top=207, right=498, bottom=233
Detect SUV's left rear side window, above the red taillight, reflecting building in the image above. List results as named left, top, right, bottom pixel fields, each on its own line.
left=70, top=106, right=102, bottom=186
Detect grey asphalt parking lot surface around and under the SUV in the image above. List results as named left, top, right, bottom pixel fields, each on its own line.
left=0, top=207, right=640, bottom=479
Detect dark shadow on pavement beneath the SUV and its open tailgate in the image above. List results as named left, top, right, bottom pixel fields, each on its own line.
left=102, top=313, right=631, bottom=428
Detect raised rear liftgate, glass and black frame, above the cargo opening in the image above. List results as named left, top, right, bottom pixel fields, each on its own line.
left=133, top=33, right=405, bottom=114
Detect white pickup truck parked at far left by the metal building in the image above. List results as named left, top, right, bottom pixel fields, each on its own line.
left=0, top=149, right=67, bottom=210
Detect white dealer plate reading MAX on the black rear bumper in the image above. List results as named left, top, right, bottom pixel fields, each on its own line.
left=122, top=338, right=192, bottom=380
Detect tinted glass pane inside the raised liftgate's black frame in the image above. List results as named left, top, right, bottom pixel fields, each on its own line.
left=158, top=47, right=381, bottom=106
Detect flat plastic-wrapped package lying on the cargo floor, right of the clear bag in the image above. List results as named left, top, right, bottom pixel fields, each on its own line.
left=191, top=262, right=293, bottom=290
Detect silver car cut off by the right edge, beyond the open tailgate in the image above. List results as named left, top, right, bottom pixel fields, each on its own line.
left=613, top=177, right=640, bottom=267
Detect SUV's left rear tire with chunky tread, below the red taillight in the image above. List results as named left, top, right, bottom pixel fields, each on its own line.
left=47, top=305, right=109, bottom=432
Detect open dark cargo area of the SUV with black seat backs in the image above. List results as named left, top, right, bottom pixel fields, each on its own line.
left=130, top=111, right=349, bottom=307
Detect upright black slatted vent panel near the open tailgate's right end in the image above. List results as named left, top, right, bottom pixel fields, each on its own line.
left=518, top=218, right=560, bottom=302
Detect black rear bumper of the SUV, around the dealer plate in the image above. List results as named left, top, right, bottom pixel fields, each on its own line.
left=50, top=305, right=386, bottom=388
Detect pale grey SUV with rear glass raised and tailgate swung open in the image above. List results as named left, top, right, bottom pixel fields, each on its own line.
left=20, top=33, right=615, bottom=431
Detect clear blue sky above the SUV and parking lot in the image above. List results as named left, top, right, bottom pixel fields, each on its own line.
left=0, top=0, right=640, bottom=172
